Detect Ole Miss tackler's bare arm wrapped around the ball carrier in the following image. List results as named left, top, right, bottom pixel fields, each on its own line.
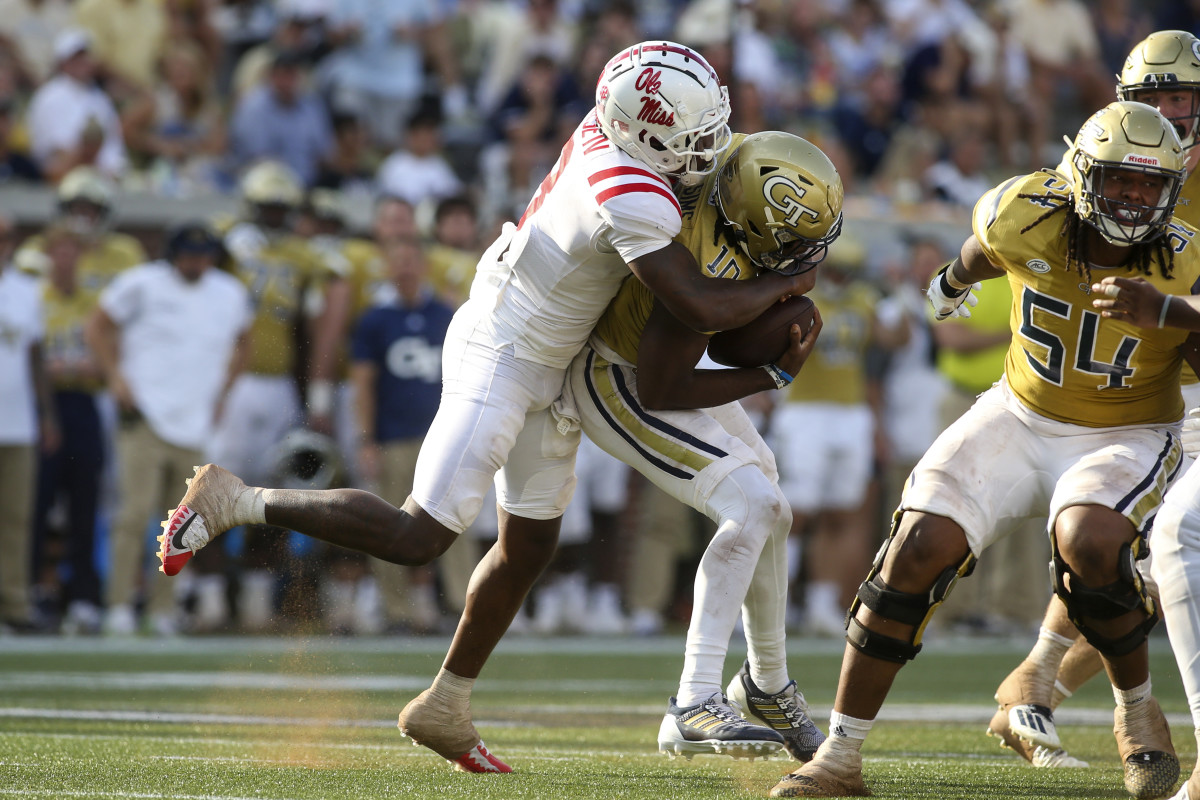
left=629, top=242, right=817, bottom=335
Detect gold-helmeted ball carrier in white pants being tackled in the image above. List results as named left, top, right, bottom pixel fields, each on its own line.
left=565, top=132, right=842, bottom=760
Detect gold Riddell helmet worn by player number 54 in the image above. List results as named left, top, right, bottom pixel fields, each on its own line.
left=1070, top=101, right=1186, bottom=245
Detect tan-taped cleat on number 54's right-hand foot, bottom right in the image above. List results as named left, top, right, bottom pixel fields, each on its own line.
left=1112, top=697, right=1180, bottom=800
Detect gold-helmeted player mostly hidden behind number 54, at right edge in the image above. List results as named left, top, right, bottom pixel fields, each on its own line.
left=988, top=30, right=1200, bottom=766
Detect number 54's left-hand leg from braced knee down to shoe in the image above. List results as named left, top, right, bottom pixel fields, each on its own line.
left=770, top=511, right=974, bottom=798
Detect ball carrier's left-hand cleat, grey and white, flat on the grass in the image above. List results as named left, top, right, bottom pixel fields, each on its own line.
left=659, top=692, right=784, bottom=760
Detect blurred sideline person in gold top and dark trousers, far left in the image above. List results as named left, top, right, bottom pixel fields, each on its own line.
left=34, top=222, right=107, bottom=633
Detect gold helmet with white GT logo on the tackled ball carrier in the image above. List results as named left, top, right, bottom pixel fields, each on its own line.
left=716, top=131, right=842, bottom=275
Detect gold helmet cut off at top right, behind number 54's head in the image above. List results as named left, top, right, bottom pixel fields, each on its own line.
left=1117, top=30, right=1200, bottom=148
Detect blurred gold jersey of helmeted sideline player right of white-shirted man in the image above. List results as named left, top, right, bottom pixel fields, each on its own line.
left=226, top=222, right=338, bottom=375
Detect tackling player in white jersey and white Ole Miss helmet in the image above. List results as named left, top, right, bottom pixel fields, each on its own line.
left=160, top=41, right=814, bottom=772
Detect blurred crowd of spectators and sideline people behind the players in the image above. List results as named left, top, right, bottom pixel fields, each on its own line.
left=0, top=0, right=1200, bottom=636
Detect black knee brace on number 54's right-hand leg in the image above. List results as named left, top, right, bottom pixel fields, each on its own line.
left=1050, top=536, right=1158, bottom=656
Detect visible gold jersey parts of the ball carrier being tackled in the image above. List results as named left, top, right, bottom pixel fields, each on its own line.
left=593, top=133, right=758, bottom=365
